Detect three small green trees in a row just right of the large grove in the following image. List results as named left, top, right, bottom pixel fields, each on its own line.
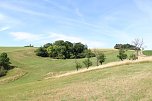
left=75, top=49, right=106, bottom=71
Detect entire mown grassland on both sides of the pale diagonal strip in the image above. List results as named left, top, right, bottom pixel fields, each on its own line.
left=0, top=48, right=152, bottom=101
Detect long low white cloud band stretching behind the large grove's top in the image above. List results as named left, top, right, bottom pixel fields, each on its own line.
left=10, top=32, right=105, bottom=48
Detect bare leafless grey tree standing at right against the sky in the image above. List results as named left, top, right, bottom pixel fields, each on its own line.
left=132, top=38, right=144, bottom=57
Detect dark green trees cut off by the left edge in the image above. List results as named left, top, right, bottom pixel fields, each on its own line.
left=0, top=53, right=12, bottom=77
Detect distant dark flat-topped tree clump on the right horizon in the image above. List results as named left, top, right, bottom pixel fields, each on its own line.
left=114, top=44, right=140, bottom=50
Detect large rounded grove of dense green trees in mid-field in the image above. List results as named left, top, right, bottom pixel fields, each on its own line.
left=35, top=40, right=95, bottom=59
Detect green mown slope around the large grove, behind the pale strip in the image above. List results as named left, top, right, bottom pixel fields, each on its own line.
left=0, top=47, right=131, bottom=84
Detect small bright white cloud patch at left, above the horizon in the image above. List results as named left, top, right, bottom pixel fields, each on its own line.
left=10, top=32, right=40, bottom=41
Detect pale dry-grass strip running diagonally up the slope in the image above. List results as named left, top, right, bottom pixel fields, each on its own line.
left=45, top=56, right=152, bottom=79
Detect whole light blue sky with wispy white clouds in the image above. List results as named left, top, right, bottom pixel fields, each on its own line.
left=0, top=0, right=152, bottom=49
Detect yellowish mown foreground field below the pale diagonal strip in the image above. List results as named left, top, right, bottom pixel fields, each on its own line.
left=0, top=63, right=152, bottom=101
